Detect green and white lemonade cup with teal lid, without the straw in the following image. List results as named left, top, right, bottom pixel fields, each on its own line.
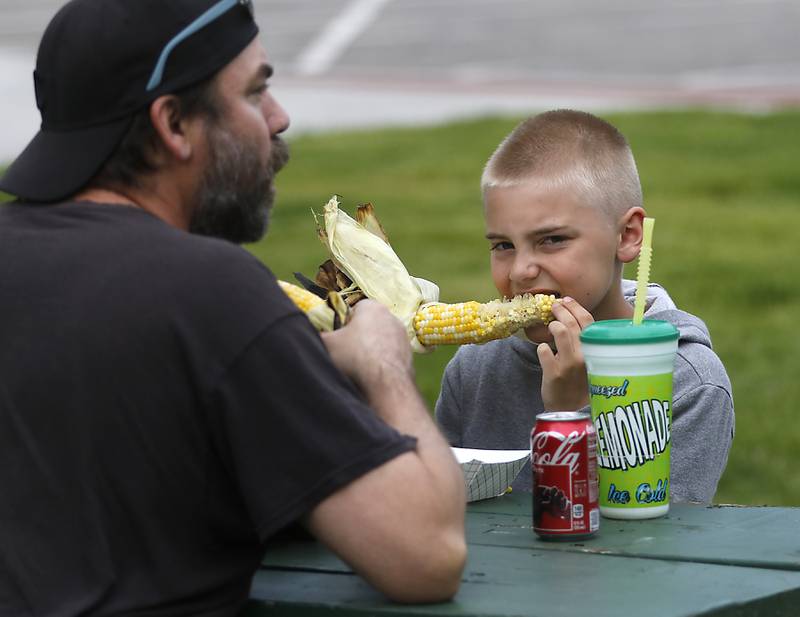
left=580, top=319, right=678, bottom=519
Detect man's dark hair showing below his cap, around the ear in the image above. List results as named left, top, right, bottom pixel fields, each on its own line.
left=88, top=78, right=222, bottom=189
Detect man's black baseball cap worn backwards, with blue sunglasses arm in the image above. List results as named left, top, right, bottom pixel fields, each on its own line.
left=0, top=0, right=258, bottom=202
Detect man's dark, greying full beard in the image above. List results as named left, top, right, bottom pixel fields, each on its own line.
left=189, top=127, right=289, bottom=244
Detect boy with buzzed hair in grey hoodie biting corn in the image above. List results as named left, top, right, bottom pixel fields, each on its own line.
left=436, top=110, right=734, bottom=503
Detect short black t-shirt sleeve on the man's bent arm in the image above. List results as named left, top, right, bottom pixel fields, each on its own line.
left=206, top=313, right=416, bottom=540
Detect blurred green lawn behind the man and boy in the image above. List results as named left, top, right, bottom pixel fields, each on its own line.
left=3, top=111, right=800, bottom=506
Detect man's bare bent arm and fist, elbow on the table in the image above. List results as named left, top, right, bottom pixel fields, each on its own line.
left=306, top=301, right=466, bottom=602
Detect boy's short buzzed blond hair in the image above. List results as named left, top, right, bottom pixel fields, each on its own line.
left=481, top=109, right=642, bottom=218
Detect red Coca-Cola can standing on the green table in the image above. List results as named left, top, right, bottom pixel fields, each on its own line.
left=531, top=411, right=600, bottom=540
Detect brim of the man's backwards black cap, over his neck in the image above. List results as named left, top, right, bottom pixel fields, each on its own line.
left=0, top=116, right=133, bottom=202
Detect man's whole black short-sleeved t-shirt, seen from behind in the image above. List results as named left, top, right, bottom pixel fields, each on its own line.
left=0, top=203, right=415, bottom=617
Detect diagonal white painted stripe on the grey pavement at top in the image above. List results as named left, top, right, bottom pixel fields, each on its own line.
left=296, top=0, right=391, bottom=76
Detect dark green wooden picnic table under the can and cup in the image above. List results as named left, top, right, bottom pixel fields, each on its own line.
left=244, top=493, right=800, bottom=617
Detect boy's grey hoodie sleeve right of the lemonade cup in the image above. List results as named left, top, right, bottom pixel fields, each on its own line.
left=670, top=383, right=734, bottom=503
